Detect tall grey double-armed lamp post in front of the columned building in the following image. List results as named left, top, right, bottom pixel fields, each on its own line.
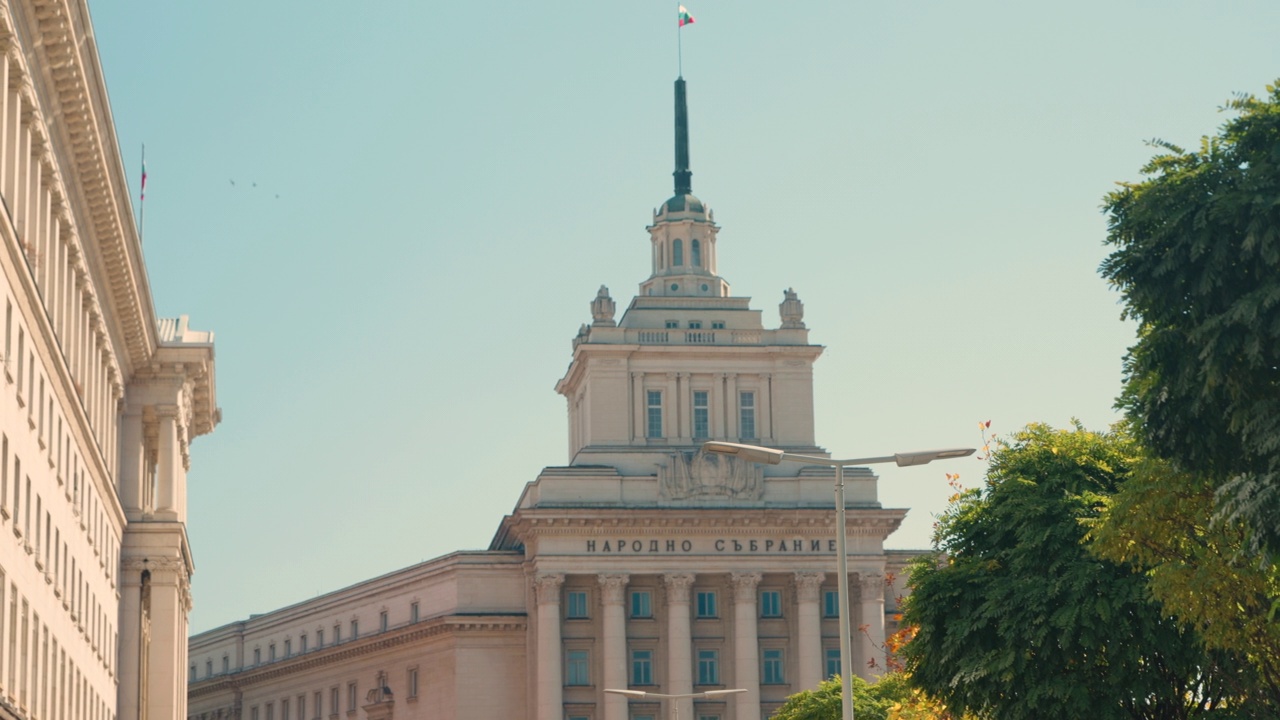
left=703, top=442, right=974, bottom=720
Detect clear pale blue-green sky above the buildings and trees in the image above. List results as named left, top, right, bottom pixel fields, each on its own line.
left=82, top=0, right=1280, bottom=632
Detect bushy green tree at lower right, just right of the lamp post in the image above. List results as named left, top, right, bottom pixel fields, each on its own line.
left=902, top=425, right=1231, bottom=720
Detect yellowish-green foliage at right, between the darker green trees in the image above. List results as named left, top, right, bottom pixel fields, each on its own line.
left=1091, top=461, right=1280, bottom=702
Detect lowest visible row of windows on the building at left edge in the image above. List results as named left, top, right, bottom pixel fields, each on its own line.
left=0, top=569, right=115, bottom=720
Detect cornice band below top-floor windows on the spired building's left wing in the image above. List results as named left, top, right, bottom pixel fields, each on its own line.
left=187, top=614, right=529, bottom=698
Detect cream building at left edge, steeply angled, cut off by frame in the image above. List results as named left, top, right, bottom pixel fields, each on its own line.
left=0, top=0, right=219, bottom=720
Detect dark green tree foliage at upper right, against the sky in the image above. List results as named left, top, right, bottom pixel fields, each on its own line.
left=1101, top=85, right=1280, bottom=552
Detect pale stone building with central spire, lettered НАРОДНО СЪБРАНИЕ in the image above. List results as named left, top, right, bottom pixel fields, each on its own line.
left=188, top=79, right=911, bottom=720
